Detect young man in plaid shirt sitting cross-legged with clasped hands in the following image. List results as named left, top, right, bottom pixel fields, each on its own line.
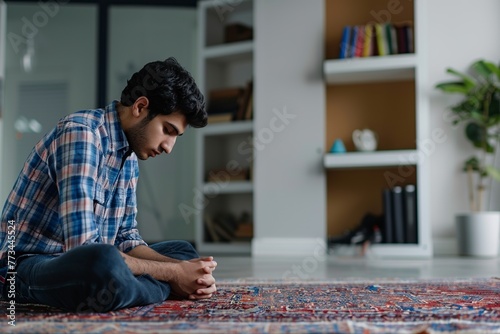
left=0, top=58, right=217, bottom=312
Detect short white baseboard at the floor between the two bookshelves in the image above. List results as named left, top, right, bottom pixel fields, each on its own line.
left=252, top=238, right=327, bottom=256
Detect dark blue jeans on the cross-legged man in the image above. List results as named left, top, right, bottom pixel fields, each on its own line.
left=8, top=241, right=199, bottom=312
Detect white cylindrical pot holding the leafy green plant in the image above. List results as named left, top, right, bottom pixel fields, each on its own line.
left=456, top=211, right=500, bottom=257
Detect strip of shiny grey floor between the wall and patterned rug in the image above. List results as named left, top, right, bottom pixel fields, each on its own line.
left=214, top=255, right=500, bottom=280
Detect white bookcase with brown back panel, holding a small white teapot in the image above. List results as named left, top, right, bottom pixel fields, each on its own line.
left=323, top=0, right=432, bottom=257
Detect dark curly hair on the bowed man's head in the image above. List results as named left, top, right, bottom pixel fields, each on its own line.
left=120, top=57, right=207, bottom=128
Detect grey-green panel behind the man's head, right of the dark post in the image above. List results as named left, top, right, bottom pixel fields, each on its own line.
left=108, top=6, right=197, bottom=242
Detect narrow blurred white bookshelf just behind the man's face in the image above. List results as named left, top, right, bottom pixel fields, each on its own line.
left=195, top=0, right=254, bottom=254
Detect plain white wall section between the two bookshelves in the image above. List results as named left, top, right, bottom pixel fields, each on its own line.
left=252, top=0, right=326, bottom=255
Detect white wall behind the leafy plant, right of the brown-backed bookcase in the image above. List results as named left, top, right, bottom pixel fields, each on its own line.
left=425, top=0, right=500, bottom=245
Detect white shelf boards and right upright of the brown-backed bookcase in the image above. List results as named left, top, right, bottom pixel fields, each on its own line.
left=323, top=0, right=432, bottom=257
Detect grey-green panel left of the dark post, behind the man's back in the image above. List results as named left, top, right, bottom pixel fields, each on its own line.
left=0, top=3, right=97, bottom=207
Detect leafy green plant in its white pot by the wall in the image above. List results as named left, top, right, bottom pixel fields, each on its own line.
left=436, top=60, right=500, bottom=256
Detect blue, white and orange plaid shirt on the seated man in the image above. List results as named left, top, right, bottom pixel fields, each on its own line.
left=0, top=101, right=146, bottom=296
